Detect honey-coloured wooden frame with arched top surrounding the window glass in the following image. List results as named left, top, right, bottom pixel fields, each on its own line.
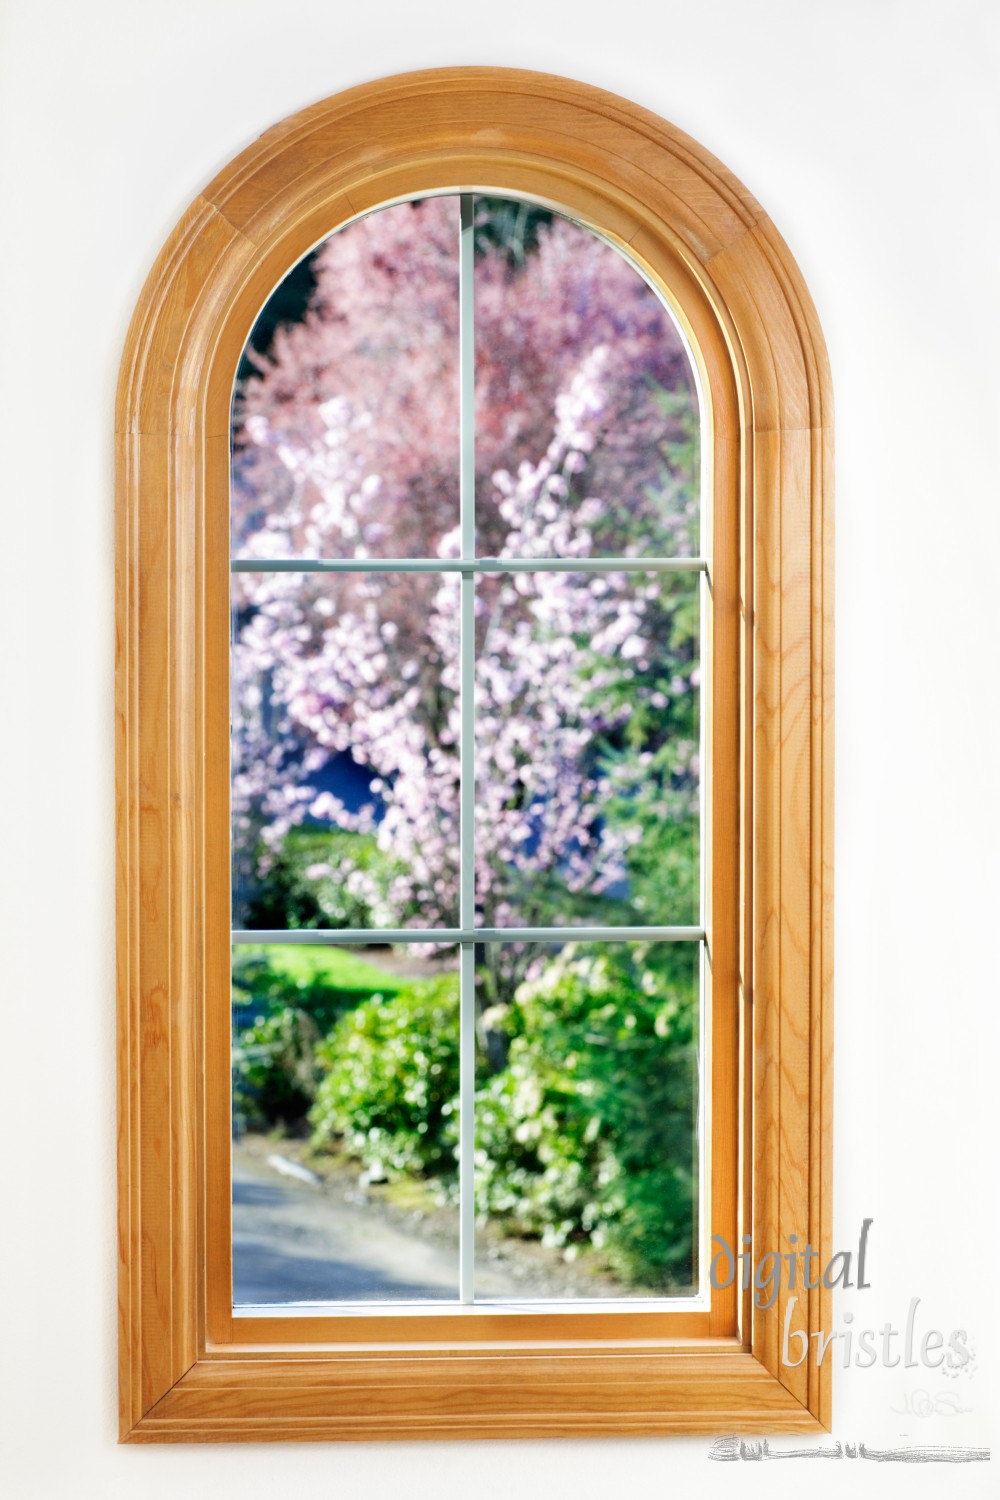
left=115, top=68, right=834, bottom=1442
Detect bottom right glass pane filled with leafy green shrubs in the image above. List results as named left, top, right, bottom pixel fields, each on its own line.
left=475, top=944, right=700, bottom=1301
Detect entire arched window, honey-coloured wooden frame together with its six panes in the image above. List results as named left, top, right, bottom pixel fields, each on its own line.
left=118, top=69, right=831, bottom=1440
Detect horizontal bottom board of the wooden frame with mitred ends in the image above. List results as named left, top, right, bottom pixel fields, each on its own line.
left=130, top=1350, right=819, bottom=1442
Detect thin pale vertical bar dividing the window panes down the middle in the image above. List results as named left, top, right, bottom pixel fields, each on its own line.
left=459, top=194, right=475, bottom=1305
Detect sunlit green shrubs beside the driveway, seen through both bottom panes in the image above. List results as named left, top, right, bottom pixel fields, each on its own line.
left=296, top=944, right=697, bottom=1290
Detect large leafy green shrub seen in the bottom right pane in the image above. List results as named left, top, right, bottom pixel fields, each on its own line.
left=477, top=945, right=697, bottom=1289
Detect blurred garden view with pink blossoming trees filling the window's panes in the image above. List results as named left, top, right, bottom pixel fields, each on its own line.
left=232, top=197, right=700, bottom=1301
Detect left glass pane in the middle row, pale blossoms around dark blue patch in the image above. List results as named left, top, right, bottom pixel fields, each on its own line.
left=232, top=573, right=459, bottom=929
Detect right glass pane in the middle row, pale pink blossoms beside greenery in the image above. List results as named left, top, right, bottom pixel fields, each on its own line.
left=475, top=572, right=702, bottom=927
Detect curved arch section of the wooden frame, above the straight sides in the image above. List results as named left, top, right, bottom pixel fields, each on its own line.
left=117, top=68, right=832, bottom=434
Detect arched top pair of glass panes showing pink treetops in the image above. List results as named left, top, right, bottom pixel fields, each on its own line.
left=232, top=194, right=700, bottom=558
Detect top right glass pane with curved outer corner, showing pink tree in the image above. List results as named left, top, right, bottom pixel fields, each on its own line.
left=475, top=198, right=699, bottom=557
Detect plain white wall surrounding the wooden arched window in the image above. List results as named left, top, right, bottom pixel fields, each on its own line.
left=0, top=0, right=1000, bottom=1500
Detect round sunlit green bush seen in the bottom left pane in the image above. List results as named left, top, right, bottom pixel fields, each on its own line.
left=309, top=974, right=459, bottom=1178
